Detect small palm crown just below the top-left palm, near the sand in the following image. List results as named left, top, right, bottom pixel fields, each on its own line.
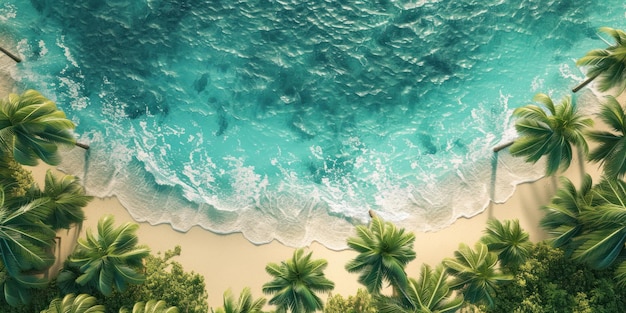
left=33, top=170, right=93, bottom=229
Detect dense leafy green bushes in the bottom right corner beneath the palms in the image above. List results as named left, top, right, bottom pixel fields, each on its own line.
left=483, top=243, right=626, bottom=313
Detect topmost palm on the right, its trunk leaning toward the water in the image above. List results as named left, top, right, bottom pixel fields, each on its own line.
left=572, top=27, right=626, bottom=94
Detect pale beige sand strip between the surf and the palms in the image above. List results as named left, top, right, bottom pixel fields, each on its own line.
left=26, top=148, right=598, bottom=307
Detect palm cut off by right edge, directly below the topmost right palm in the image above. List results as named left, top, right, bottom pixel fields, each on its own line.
left=587, top=96, right=626, bottom=178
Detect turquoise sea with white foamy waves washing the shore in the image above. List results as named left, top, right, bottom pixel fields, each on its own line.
left=0, top=0, right=626, bottom=249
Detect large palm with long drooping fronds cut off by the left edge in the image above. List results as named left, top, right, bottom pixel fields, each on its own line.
left=0, top=188, right=55, bottom=306
